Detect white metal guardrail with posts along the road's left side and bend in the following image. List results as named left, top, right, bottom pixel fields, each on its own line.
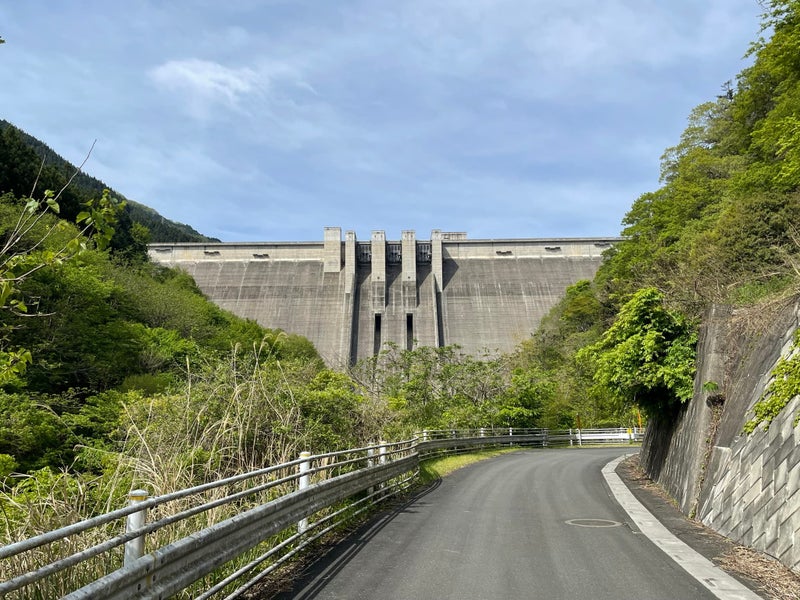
left=0, top=428, right=644, bottom=600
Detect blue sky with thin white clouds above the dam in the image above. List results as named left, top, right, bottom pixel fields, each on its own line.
left=0, top=0, right=761, bottom=241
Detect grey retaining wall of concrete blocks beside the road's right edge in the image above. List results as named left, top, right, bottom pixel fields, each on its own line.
left=642, top=304, right=800, bottom=573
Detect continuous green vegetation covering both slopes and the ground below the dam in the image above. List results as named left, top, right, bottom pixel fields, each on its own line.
left=0, top=0, right=800, bottom=552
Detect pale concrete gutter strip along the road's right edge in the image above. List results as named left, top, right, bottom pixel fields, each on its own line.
left=603, top=454, right=762, bottom=600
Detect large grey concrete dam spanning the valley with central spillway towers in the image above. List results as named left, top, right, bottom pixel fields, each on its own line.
left=149, top=227, right=619, bottom=367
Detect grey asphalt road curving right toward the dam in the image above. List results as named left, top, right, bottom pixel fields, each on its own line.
left=278, top=448, right=714, bottom=600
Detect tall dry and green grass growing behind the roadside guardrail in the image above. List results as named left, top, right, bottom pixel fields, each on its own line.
left=0, top=352, right=379, bottom=600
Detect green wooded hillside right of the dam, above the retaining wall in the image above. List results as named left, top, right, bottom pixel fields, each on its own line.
left=510, top=0, right=800, bottom=432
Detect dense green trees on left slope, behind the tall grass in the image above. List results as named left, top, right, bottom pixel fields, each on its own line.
left=0, top=188, right=344, bottom=471
